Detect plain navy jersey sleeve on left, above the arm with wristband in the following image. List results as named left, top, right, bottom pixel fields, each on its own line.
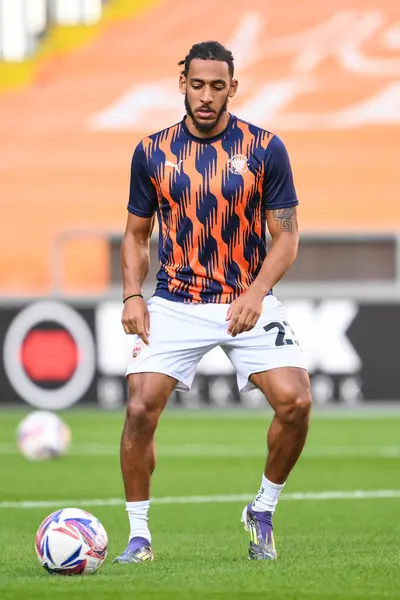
left=128, top=142, right=157, bottom=217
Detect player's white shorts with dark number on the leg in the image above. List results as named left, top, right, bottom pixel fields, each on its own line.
left=126, top=295, right=306, bottom=392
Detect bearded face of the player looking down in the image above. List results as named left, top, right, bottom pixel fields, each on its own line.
left=179, top=58, right=237, bottom=134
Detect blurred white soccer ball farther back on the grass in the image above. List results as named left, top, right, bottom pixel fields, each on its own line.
left=17, top=410, right=71, bottom=460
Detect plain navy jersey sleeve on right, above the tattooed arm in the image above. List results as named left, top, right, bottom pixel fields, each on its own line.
left=263, top=135, right=299, bottom=210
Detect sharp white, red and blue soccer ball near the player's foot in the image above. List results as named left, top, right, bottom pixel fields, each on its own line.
left=36, top=508, right=108, bottom=575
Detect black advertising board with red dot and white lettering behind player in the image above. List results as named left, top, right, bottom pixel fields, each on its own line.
left=0, top=299, right=400, bottom=410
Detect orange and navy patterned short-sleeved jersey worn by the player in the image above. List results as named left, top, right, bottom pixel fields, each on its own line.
left=128, top=115, right=298, bottom=303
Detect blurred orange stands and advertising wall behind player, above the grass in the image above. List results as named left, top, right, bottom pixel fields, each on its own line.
left=0, top=0, right=400, bottom=409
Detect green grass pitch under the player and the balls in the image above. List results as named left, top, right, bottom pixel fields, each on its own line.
left=0, top=409, right=400, bottom=600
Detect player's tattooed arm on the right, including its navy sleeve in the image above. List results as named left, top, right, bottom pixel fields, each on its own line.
left=227, top=137, right=299, bottom=337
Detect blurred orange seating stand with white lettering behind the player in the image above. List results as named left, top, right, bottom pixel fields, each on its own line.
left=0, top=0, right=400, bottom=294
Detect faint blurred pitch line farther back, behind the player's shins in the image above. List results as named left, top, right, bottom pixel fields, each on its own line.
left=0, top=444, right=400, bottom=458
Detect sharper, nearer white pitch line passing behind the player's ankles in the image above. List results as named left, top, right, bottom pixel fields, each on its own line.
left=0, top=490, right=400, bottom=509
